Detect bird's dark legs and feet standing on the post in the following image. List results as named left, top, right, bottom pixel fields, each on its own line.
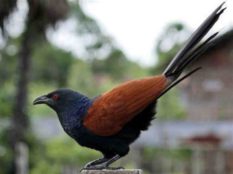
left=82, top=155, right=122, bottom=170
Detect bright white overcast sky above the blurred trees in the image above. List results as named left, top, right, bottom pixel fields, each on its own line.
left=76, top=0, right=233, bottom=66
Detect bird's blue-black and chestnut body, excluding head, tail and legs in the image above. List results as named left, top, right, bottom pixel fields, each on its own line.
left=50, top=75, right=168, bottom=160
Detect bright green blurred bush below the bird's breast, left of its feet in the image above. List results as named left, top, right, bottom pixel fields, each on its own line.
left=31, top=137, right=101, bottom=174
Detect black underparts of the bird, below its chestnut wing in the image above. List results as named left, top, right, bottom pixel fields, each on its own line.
left=62, top=103, right=156, bottom=155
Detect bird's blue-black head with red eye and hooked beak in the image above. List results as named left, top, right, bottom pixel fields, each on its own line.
left=33, top=89, right=89, bottom=112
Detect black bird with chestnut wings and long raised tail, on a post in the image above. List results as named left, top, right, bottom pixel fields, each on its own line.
left=33, top=2, right=226, bottom=170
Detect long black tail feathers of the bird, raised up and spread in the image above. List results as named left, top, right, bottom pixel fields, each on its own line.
left=159, top=2, right=226, bottom=97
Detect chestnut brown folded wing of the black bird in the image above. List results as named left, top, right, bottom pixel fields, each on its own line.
left=83, top=75, right=168, bottom=136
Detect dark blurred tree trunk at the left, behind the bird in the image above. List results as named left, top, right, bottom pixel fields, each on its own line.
left=10, top=31, right=33, bottom=173
